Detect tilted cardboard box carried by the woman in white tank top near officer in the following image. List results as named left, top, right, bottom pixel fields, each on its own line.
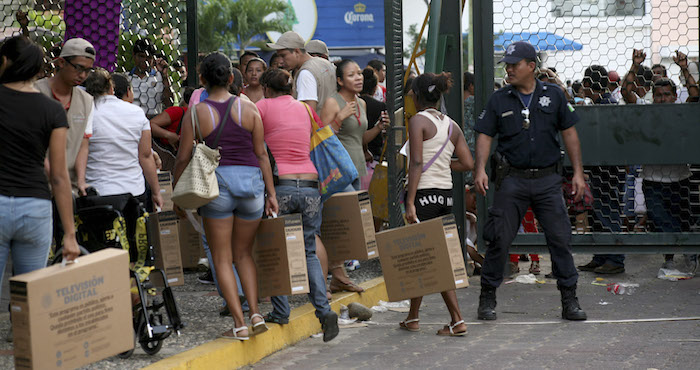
left=377, top=215, right=469, bottom=301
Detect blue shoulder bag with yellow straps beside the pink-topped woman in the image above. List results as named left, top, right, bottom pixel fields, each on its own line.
left=302, top=103, right=359, bottom=202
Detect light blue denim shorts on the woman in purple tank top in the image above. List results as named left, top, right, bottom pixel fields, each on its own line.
left=199, top=166, right=265, bottom=220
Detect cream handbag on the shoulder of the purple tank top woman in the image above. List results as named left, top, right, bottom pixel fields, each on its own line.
left=172, top=97, right=241, bottom=209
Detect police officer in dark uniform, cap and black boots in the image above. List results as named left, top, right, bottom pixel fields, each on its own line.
left=474, top=42, right=586, bottom=320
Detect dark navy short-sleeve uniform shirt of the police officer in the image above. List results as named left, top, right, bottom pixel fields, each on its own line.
left=474, top=80, right=579, bottom=168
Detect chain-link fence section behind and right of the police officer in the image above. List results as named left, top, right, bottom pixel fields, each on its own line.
left=492, top=0, right=700, bottom=240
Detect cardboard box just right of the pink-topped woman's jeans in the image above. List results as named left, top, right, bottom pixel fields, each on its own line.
left=321, top=190, right=378, bottom=261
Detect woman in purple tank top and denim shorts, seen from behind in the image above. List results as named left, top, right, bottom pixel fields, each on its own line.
left=174, top=53, right=279, bottom=340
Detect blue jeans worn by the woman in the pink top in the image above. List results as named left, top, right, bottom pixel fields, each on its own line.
left=272, top=186, right=331, bottom=320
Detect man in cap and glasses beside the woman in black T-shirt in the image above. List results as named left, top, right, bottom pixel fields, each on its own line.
left=35, top=38, right=96, bottom=195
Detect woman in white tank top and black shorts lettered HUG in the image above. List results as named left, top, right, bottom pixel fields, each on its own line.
left=399, top=73, right=474, bottom=336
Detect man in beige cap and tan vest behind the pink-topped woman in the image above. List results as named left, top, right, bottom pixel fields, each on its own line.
left=267, top=31, right=336, bottom=112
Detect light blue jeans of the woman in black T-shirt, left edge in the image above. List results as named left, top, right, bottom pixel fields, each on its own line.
left=0, top=195, right=53, bottom=302
